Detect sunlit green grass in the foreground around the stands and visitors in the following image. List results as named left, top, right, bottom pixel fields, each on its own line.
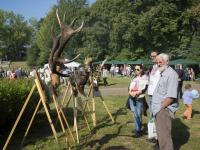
left=1, top=96, right=200, bottom=150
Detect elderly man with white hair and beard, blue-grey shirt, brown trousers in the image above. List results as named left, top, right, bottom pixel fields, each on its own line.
left=152, top=53, right=178, bottom=150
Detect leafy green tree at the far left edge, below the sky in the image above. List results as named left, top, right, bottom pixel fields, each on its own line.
left=0, top=11, right=31, bottom=60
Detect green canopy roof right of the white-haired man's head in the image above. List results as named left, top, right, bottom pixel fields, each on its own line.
left=169, top=59, right=200, bottom=65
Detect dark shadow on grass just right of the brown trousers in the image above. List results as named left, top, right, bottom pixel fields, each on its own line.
left=172, top=118, right=190, bottom=150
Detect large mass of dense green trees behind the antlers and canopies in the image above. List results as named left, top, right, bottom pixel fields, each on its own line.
left=0, top=0, right=200, bottom=65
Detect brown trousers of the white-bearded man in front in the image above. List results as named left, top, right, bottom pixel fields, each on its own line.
left=155, top=109, right=174, bottom=150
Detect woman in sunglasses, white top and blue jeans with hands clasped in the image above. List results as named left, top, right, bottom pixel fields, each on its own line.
left=129, top=65, right=148, bottom=138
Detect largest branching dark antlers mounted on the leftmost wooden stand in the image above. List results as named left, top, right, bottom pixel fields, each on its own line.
left=48, top=9, right=84, bottom=92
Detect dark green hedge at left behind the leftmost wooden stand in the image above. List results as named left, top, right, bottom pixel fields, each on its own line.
left=0, top=79, right=39, bottom=125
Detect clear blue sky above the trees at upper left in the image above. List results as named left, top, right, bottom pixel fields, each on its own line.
left=0, top=0, right=96, bottom=20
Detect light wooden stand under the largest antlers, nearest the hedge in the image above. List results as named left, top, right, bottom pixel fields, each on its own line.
left=3, top=71, right=75, bottom=150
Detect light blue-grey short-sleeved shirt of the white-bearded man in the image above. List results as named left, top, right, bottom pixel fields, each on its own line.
left=152, top=66, right=178, bottom=116
